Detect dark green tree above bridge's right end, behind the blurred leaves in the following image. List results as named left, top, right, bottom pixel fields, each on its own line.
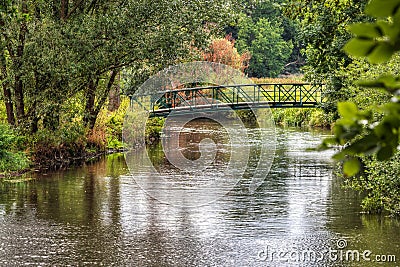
left=284, top=0, right=368, bottom=113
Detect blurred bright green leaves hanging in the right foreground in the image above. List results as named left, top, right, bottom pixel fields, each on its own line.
left=321, top=0, right=400, bottom=176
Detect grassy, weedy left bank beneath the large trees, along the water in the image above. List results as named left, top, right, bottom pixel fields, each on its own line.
left=0, top=97, right=129, bottom=176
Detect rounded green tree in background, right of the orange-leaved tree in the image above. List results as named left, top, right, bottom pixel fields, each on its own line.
left=231, top=0, right=303, bottom=78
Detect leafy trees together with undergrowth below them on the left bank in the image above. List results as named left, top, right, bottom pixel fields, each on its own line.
left=0, top=0, right=238, bottom=171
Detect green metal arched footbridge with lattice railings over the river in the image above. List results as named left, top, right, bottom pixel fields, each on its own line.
left=130, top=83, right=325, bottom=117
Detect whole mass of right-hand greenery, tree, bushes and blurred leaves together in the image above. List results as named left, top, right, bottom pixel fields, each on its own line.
left=288, top=0, right=400, bottom=214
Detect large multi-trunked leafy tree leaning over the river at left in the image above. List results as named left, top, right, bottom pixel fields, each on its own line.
left=0, top=0, right=236, bottom=132
